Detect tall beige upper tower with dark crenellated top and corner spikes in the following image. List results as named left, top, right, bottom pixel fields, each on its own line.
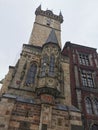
left=29, top=5, right=63, bottom=46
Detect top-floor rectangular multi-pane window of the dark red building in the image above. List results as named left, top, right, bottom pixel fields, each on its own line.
left=79, top=54, right=90, bottom=66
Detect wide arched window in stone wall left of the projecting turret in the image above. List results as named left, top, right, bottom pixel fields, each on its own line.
left=26, top=63, right=37, bottom=85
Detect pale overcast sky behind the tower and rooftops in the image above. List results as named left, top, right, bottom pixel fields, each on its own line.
left=0, top=0, right=98, bottom=84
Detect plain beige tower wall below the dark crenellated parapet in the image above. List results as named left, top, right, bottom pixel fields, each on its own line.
left=29, top=15, right=61, bottom=46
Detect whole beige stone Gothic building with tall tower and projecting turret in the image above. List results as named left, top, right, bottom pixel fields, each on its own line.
left=0, top=6, right=83, bottom=130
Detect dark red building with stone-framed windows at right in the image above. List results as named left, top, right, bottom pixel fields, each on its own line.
left=62, top=42, right=98, bottom=130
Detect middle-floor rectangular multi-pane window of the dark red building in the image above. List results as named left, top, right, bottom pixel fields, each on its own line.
left=81, top=71, right=94, bottom=88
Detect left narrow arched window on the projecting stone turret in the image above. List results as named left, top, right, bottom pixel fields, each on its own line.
left=41, top=55, right=48, bottom=76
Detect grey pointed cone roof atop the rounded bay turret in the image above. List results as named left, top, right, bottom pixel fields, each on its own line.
left=46, top=29, right=58, bottom=44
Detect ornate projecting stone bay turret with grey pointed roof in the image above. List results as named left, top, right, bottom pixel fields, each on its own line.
left=36, top=29, right=62, bottom=103
